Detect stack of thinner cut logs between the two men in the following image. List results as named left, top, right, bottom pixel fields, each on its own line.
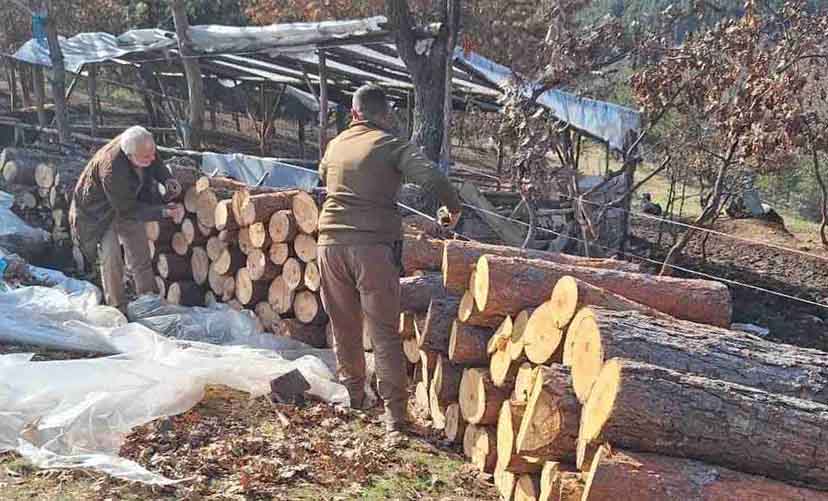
left=147, top=169, right=327, bottom=347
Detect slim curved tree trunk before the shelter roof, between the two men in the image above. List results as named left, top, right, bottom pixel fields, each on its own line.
left=170, top=0, right=204, bottom=149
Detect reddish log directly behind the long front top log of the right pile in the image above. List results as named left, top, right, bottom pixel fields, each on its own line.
left=440, top=240, right=639, bottom=294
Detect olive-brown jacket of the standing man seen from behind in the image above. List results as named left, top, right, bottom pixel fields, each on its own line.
left=319, top=121, right=460, bottom=245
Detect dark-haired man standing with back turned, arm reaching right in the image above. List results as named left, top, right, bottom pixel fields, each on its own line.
left=319, top=85, right=461, bottom=432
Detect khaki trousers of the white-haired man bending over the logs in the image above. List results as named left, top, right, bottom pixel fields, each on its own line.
left=99, top=221, right=156, bottom=308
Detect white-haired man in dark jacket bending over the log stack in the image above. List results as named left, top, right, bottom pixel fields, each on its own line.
left=69, top=126, right=184, bottom=311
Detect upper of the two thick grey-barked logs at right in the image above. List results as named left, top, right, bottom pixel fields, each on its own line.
left=566, top=308, right=828, bottom=404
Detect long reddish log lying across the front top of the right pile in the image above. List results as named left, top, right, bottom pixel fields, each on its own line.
left=474, top=255, right=731, bottom=326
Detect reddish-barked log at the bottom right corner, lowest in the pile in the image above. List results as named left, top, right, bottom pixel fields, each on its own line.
left=583, top=446, right=828, bottom=501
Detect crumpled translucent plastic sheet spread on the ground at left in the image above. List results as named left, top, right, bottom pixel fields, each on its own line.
left=0, top=283, right=349, bottom=485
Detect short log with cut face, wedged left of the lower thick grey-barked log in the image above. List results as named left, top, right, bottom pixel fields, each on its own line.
left=515, top=364, right=581, bottom=462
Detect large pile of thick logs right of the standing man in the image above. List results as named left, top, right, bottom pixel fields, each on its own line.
left=400, top=240, right=828, bottom=501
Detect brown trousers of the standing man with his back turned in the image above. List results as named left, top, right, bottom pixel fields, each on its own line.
left=319, top=245, right=408, bottom=422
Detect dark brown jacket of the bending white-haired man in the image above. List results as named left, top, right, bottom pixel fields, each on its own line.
left=70, top=136, right=171, bottom=257
